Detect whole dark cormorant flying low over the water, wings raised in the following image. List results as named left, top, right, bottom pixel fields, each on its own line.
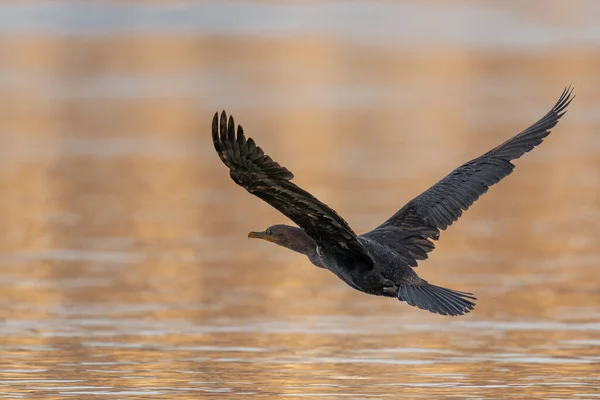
left=212, top=87, right=574, bottom=315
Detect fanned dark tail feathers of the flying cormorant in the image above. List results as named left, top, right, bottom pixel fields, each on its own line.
left=398, top=281, right=477, bottom=315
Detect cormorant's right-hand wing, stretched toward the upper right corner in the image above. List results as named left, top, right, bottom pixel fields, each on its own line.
left=363, top=87, right=574, bottom=267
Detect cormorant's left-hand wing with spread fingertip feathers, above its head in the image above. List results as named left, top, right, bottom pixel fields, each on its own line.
left=212, top=111, right=373, bottom=270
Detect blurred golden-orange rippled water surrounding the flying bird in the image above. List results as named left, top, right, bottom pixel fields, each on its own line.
left=0, top=0, right=600, bottom=399
